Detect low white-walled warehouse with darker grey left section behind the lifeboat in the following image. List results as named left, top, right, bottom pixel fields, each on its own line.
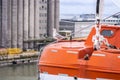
left=59, top=21, right=94, bottom=37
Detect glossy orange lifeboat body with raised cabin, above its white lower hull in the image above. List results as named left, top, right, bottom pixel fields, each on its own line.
left=38, top=25, right=120, bottom=80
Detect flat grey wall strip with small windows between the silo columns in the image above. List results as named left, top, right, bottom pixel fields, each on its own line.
left=39, top=0, right=49, bottom=39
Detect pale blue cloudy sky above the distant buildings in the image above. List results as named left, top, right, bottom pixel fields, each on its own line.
left=60, top=0, right=120, bottom=16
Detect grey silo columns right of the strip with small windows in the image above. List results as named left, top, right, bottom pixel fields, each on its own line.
left=47, top=0, right=59, bottom=37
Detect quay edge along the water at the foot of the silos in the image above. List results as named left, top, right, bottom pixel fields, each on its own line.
left=0, top=51, right=39, bottom=67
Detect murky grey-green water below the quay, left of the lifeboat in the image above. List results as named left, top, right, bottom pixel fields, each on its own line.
left=0, top=63, right=37, bottom=80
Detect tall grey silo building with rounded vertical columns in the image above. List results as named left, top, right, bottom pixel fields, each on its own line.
left=0, top=0, right=59, bottom=49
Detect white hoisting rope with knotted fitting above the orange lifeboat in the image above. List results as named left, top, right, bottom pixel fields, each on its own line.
left=92, top=0, right=109, bottom=50
